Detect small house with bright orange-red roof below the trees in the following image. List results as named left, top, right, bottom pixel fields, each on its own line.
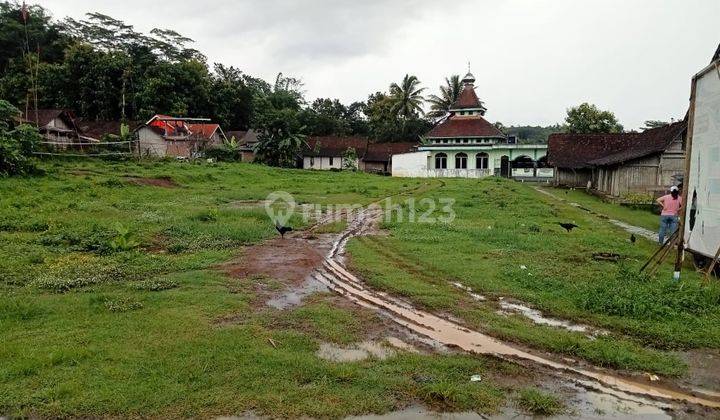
left=136, top=115, right=225, bottom=158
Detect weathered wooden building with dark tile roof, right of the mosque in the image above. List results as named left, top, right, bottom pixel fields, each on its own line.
left=548, top=121, right=687, bottom=197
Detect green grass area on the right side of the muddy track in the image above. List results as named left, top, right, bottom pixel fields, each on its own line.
left=349, top=178, right=720, bottom=375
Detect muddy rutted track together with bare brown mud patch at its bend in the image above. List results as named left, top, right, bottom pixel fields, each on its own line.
left=223, top=201, right=720, bottom=418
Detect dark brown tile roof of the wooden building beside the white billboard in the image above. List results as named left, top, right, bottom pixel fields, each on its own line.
left=548, top=121, right=687, bottom=169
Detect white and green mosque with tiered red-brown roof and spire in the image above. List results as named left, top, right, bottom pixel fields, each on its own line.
left=393, top=72, right=552, bottom=179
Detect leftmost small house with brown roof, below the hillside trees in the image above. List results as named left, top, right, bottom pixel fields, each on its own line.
left=21, top=109, right=82, bottom=148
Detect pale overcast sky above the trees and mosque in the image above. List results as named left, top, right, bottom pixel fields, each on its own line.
left=40, top=0, right=720, bottom=129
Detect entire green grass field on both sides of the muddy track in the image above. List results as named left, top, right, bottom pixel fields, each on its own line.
left=0, top=161, right=720, bottom=417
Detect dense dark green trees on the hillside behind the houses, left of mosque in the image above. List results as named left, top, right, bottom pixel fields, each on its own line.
left=0, top=2, right=430, bottom=141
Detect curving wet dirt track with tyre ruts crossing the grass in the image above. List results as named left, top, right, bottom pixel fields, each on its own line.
left=315, top=207, right=720, bottom=408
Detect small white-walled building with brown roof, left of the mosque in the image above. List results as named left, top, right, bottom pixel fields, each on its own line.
left=302, top=136, right=369, bottom=170
